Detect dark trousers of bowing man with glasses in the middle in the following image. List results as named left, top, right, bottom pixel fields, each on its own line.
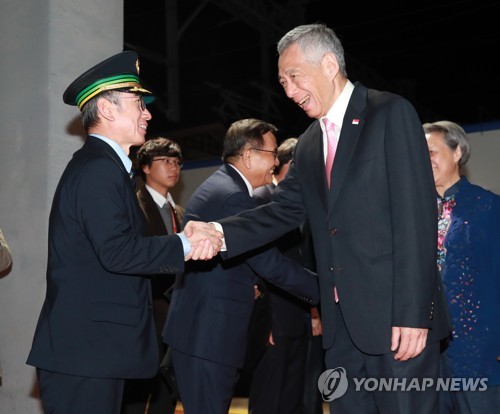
left=172, top=348, right=238, bottom=414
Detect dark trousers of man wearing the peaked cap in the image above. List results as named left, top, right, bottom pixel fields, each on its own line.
left=37, top=369, right=124, bottom=414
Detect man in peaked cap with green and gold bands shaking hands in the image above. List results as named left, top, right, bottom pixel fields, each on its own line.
left=27, top=51, right=220, bottom=414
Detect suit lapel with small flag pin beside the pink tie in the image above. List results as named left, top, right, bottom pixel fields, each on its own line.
left=325, top=84, right=367, bottom=214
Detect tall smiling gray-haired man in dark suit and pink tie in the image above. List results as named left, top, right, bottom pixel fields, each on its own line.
left=216, top=24, right=450, bottom=414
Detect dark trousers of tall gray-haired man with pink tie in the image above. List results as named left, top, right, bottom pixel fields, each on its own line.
left=325, top=304, right=439, bottom=414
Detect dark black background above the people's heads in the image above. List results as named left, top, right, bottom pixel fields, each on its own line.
left=124, top=0, right=500, bottom=160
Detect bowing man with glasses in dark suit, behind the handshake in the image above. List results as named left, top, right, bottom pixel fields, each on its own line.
left=163, top=119, right=319, bottom=414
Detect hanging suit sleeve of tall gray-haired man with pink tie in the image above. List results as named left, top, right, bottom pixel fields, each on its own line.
left=385, top=100, right=438, bottom=328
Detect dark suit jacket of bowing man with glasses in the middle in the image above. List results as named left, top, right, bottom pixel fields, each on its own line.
left=163, top=164, right=318, bottom=368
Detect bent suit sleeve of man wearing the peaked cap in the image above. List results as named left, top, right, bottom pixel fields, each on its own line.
left=71, top=159, right=184, bottom=274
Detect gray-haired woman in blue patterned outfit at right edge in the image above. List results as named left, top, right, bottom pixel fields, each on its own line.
left=423, top=121, right=500, bottom=414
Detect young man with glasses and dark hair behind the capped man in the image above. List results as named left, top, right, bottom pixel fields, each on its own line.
left=122, top=137, right=184, bottom=414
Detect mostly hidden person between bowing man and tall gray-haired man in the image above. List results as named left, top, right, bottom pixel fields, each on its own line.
left=248, top=138, right=321, bottom=414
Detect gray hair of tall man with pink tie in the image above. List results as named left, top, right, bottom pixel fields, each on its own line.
left=277, top=23, right=347, bottom=77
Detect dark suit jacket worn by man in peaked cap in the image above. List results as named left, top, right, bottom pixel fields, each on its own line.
left=27, top=137, right=184, bottom=378
